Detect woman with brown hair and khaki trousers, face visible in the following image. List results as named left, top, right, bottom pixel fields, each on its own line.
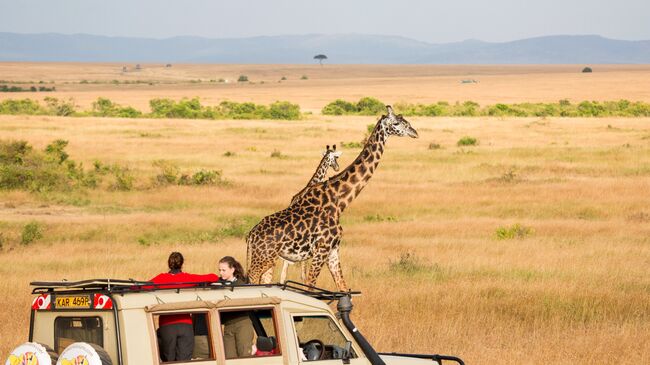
left=219, top=256, right=255, bottom=359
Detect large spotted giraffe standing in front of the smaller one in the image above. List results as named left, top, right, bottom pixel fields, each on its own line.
left=246, top=106, right=418, bottom=291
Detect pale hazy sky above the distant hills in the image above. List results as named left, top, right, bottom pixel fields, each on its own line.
left=0, top=0, right=650, bottom=43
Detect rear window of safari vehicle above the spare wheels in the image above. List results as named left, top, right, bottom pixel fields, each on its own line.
left=54, top=317, right=104, bottom=354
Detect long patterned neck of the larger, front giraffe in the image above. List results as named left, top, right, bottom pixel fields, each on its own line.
left=327, top=120, right=388, bottom=212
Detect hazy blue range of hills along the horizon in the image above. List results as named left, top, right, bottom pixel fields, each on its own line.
left=0, top=32, right=650, bottom=64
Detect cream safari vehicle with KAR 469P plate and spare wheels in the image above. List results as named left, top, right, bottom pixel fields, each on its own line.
left=5, top=279, right=464, bottom=365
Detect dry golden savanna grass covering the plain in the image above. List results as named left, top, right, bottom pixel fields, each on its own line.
left=0, top=64, right=650, bottom=364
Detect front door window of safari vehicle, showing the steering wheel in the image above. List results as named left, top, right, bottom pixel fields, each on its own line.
left=293, top=316, right=357, bottom=361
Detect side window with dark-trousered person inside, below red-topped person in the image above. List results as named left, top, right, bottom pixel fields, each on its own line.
left=154, top=312, right=215, bottom=363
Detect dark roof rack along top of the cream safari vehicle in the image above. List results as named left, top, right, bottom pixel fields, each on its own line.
left=30, top=279, right=361, bottom=301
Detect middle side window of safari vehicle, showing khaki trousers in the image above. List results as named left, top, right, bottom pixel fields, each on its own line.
left=219, top=309, right=281, bottom=359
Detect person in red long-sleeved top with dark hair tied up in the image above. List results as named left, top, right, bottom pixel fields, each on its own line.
left=149, top=252, right=219, bottom=362
